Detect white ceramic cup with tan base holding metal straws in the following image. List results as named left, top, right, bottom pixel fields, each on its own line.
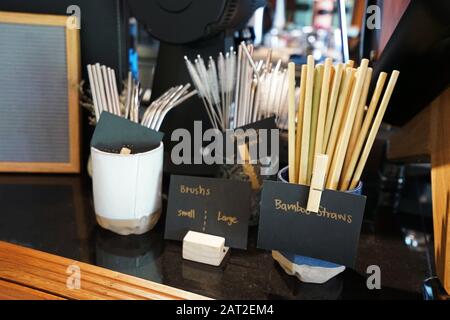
left=91, top=142, right=164, bottom=235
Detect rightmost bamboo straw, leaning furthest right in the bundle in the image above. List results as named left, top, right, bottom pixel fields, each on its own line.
left=350, top=70, right=400, bottom=189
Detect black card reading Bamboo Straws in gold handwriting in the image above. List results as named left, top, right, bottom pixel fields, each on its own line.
left=258, top=181, right=366, bottom=267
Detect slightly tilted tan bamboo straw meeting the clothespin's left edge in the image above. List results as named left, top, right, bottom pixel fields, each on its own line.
left=306, top=65, right=324, bottom=185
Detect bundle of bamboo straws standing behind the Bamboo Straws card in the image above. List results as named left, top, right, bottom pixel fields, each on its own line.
left=288, top=56, right=399, bottom=191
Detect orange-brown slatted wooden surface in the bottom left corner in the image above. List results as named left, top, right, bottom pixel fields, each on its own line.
left=0, top=242, right=208, bottom=300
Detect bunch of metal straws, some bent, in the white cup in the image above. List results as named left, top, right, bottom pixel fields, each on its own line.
left=87, top=63, right=197, bottom=130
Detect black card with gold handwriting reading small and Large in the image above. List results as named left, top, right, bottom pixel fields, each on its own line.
left=164, top=175, right=251, bottom=249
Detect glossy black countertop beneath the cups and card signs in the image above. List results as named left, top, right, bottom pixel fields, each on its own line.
left=0, top=174, right=429, bottom=300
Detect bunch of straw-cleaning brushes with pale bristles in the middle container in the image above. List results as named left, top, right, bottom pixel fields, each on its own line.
left=185, top=43, right=288, bottom=131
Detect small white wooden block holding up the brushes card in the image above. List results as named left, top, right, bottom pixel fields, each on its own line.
left=183, top=231, right=229, bottom=266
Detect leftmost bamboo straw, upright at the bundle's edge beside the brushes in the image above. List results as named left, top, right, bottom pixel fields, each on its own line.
left=288, top=62, right=296, bottom=183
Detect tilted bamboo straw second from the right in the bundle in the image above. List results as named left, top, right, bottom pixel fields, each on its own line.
left=340, top=72, right=387, bottom=191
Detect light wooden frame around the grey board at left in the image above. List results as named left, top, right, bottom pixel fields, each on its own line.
left=0, top=12, right=81, bottom=173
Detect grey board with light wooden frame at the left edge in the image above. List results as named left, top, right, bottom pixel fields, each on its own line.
left=0, top=12, right=80, bottom=173
